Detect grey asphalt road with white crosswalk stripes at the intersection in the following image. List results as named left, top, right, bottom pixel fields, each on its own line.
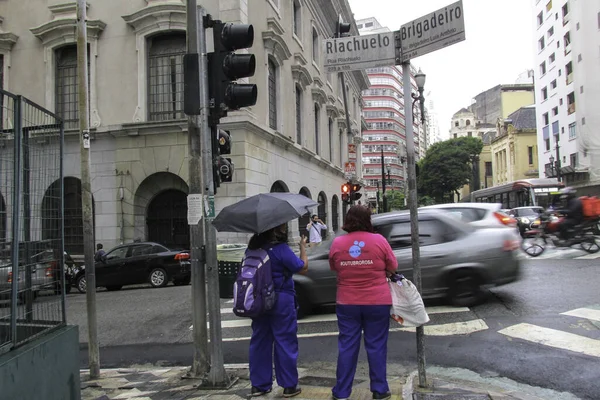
left=68, top=259, right=600, bottom=399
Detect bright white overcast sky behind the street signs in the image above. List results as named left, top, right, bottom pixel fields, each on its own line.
left=349, top=0, right=535, bottom=139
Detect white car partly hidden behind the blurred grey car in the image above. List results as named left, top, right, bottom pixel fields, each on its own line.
left=422, top=203, right=517, bottom=228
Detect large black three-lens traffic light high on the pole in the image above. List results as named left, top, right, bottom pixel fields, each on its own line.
left=208, top=20, right=258, bottom=126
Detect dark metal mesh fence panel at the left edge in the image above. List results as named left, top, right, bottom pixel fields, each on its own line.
left=0, top=90, right=66, bottom=354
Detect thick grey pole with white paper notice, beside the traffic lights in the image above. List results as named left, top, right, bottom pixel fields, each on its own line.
left=184, top=0, right=212, bottom=377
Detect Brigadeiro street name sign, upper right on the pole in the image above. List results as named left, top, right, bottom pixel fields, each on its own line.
left=396, top=0, right=465, bottom=62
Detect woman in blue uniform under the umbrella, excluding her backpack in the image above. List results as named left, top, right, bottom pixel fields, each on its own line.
left=248, top=224, right=308, bottom=397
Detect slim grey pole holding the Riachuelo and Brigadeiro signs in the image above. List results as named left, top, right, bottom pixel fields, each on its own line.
left=402, top=61, right=427, bottom=387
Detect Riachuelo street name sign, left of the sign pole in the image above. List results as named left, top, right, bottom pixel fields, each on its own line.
left=323, top=32, right=396, bottom=72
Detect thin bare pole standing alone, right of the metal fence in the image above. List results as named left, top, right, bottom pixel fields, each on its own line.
left=77, top=0, right=100, bottom=379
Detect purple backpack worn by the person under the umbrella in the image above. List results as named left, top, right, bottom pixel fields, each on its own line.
left=233, top=249, right=276, bottom=318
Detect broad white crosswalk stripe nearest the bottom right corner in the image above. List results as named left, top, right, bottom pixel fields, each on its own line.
left=498, top=323, right=600, bottom=357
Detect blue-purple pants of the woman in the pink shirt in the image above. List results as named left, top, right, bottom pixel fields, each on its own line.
left=332, top=304, right=390, bottom=398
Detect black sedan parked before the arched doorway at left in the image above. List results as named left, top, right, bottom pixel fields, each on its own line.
left=75, top=242, right=191, bottom=293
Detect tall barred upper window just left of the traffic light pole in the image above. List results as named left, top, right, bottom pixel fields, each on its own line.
left=148, top=33, right=186, bottom=121
